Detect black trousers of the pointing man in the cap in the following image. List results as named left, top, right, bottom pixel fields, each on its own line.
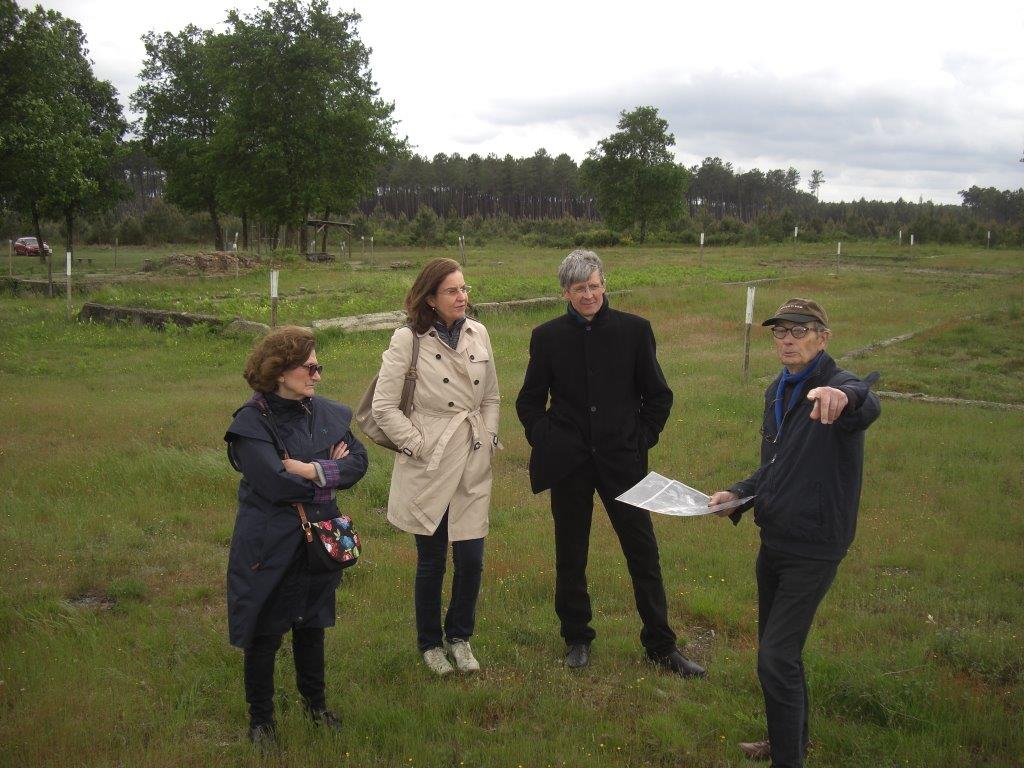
left=757, top=546, right=839, bottom=768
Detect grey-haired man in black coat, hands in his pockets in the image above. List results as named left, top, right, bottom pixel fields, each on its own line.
left=516, top=251, right=705, bottom=677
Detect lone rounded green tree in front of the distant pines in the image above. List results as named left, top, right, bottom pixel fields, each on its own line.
left=580, top=106, right=688, bottom=243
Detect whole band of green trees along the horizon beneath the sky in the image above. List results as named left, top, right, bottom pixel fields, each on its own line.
left=0, top=0, right=1024, bottom=260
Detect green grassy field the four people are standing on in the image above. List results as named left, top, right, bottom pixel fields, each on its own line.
left=0, top=244, right=1024, bottom=768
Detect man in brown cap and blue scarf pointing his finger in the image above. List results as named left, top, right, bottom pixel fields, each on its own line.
left=709, top=298, right=882, bottom=768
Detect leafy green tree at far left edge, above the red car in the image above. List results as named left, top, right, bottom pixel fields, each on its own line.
left=0, top=0, right=126, bottom=295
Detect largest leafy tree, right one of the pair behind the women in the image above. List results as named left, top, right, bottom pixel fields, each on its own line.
left=215, top=0, right=402, bottom=236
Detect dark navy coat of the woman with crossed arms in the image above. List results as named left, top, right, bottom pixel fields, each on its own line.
left=224, top=396, right=369, bottom=648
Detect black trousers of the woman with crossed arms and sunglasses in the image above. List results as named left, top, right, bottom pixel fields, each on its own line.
left=245, top=629, right=327, bottom=726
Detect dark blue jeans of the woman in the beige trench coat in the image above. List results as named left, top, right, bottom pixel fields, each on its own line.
left=415, top=513, right=483, bottom=651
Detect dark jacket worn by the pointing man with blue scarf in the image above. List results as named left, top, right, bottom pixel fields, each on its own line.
left=729, top=352, right=882, bottom=560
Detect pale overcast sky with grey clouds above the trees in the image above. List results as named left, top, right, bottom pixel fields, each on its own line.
left=48, top=0, right=1024, bottom=203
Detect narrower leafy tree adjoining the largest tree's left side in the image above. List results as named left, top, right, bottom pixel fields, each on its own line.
left=131, top=25, right=225, bottom=250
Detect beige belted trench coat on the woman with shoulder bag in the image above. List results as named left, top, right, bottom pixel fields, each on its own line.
left=373, top=317, right=501, bottom=542
